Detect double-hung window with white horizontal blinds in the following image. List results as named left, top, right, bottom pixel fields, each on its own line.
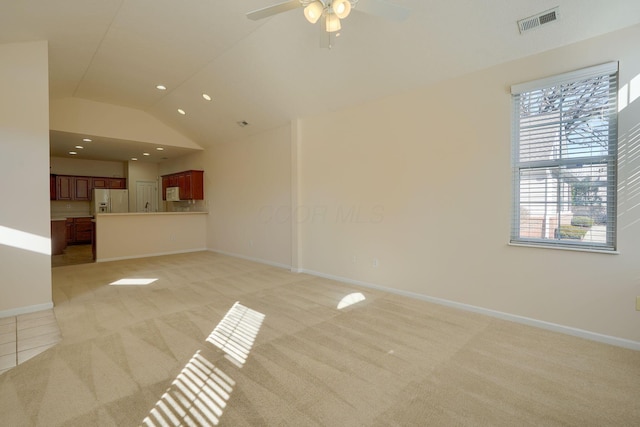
left=511, top=63, right=618, bottom=251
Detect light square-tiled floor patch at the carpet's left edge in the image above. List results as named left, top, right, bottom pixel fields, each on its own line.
left=0, top=310, right=62, bottom=374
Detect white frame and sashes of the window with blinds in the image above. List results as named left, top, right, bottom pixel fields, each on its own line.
left=510, top=62, right=619, bottom=253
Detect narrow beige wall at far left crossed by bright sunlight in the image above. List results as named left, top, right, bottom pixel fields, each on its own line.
left=0, top=42, right=52, bottom=317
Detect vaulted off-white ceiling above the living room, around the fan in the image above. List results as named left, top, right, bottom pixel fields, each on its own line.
left=0, top=0, right=640, bottom=162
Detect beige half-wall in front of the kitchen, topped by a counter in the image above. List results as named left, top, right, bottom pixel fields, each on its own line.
left=94, top=212, right=208, bottom=262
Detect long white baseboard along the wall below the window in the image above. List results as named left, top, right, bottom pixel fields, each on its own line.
left=297, top=269, right=640, bottom=351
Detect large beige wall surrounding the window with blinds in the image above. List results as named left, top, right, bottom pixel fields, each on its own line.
left=299, top=26, right=640, bottom=348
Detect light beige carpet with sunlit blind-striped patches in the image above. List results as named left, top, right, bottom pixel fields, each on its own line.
left=0, top=252, right=640, bottom=427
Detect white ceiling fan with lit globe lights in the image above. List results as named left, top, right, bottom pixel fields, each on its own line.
left=247, top=0, right=411, bottom=47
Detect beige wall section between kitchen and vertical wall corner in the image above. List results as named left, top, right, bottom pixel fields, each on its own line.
left=202, top=126, right=291, bottom=267
